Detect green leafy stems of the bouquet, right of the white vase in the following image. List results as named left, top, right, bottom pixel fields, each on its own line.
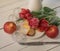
left=31, top=6, right=60, bottom=26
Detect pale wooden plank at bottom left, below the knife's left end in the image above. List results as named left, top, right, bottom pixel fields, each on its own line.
left=0, top=43, right=27, bottom=51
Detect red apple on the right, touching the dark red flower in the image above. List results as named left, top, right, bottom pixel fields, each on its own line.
left=45, top=25, right=59, bottom=38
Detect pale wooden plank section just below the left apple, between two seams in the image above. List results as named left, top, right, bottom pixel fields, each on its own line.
left=0, top=30, right=14, bottom=48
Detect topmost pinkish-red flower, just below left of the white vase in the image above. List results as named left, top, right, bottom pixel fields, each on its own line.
left=19, top=9, right=32, bottom=20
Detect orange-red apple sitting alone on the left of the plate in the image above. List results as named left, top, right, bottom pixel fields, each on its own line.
left=4, top=22, right=16, bottom=34
